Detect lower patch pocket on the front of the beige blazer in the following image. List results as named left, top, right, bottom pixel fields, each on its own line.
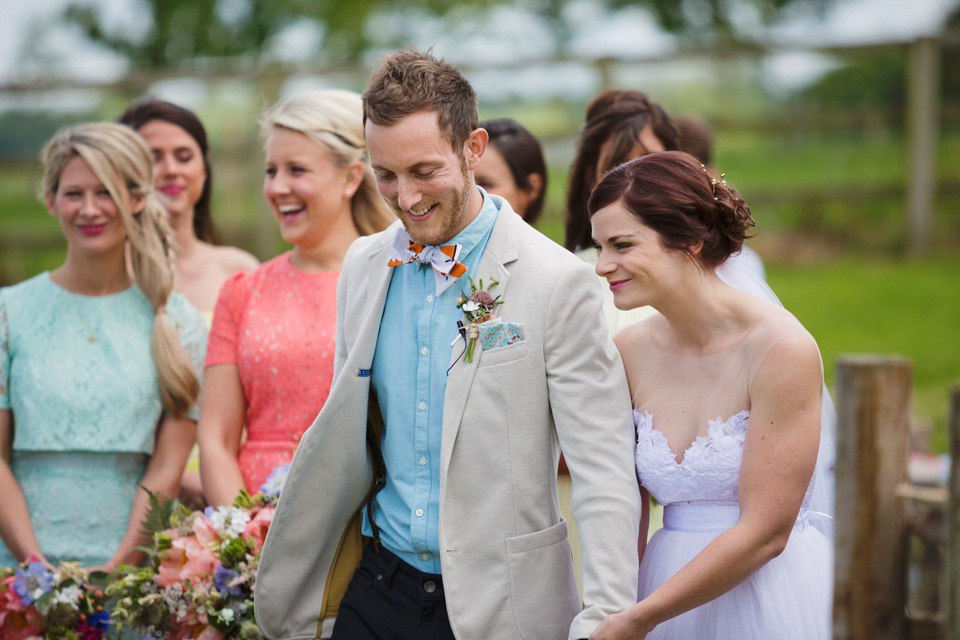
left=506, top=518, right=582, bottom=640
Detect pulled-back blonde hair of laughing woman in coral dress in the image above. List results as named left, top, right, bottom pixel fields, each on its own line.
left=260, top=89, right=394, bottom=235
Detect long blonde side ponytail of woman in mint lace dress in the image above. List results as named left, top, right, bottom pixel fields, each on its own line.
left=40, top=122, right=200, bottom=417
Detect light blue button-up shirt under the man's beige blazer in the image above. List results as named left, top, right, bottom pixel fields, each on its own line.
left=363, top=187, right=503, bottom=573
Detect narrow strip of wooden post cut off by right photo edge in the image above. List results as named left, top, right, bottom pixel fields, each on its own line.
left=943, top=384, right=960, bottom=640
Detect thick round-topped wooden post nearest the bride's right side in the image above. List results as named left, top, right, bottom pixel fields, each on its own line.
left=833, top=356, right=911, bottom=640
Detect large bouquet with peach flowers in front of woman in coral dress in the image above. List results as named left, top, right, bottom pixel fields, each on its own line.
left=106, top=465, right=289, bottom=640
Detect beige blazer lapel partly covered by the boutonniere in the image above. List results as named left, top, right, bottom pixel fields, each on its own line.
left=440, top=211, right=526, bottom=471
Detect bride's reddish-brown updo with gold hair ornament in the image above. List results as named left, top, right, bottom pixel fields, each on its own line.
left=588, top=151, right=755, bottom=267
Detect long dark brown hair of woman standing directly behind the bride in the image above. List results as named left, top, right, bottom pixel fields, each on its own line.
left=564, top=89, right=679, bottom=251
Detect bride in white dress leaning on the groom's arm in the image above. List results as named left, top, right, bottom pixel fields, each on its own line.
left=589, top=151, right=832, bottom=640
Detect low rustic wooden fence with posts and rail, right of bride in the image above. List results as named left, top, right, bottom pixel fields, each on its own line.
left=833, top=356, right=960, bottom=640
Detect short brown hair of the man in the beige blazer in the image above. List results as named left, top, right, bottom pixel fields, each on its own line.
left=363, top=49, right=479, bottom=156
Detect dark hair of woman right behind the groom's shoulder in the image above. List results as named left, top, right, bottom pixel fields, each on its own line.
left=480, top=118, right=547, bottom=224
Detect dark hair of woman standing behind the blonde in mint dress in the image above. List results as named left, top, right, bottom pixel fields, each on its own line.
left=119, top=98, right=220, bottom=244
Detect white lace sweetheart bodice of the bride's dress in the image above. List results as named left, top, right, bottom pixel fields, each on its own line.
left=633, top=411, right=750, bottom=504
